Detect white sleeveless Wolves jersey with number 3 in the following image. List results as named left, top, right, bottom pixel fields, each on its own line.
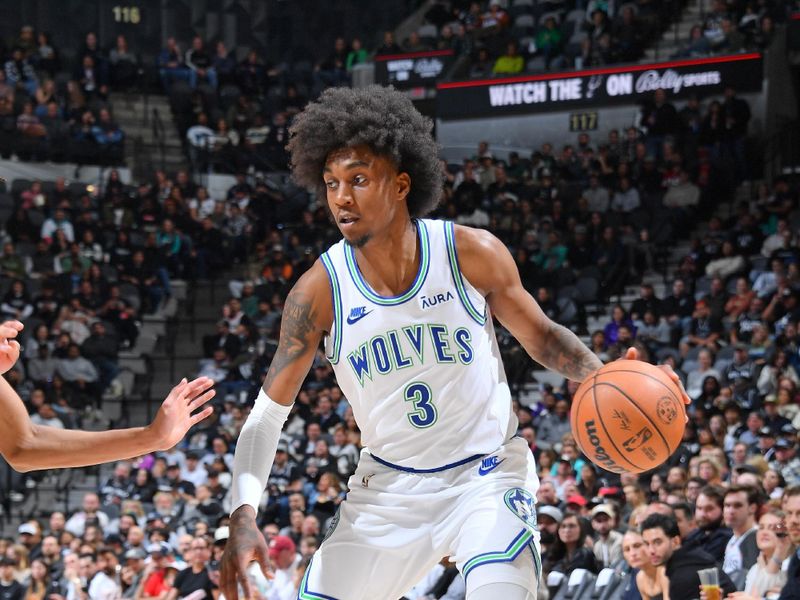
left=322, top=219, right=517, bottom=471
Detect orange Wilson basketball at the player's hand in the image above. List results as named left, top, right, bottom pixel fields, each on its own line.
left=570, top=360, right=686, bottom=473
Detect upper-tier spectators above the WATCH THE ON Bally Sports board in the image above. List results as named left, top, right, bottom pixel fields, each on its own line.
left=418, top=0, right=793, bottom=78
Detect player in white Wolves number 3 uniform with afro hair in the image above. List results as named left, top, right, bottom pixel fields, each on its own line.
left=220, top=86, right=688, bottom=600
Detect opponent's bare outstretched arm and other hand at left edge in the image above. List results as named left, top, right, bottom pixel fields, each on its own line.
left=0, top=321, right=215, bottom=471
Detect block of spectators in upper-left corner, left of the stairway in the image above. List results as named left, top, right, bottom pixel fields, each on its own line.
left=0, top=26, right=126, bottom=165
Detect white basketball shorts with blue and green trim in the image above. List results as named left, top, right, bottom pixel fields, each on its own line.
left=298, top=438, right=541, bottom=600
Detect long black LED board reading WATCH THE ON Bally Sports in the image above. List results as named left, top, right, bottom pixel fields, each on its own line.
left=436, top=53, right=764, bottom=120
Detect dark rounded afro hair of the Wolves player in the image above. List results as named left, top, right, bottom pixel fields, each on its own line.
left=287, top=85, right=443, bottom=218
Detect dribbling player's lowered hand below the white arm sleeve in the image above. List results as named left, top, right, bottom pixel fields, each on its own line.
left=219, top=505, right=273, bottom=600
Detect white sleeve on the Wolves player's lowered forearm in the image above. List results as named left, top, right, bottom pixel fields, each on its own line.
left=231, top=389, right=292, bottom=514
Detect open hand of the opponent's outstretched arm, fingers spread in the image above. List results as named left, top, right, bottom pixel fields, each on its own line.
left=148, top=377, right=216, bottom=450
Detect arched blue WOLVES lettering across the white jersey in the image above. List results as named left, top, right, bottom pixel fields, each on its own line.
left=347, top=324, right=475, bottom=386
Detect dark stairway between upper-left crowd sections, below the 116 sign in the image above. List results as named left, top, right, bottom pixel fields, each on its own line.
left=110, top=92, right=187, bottom=176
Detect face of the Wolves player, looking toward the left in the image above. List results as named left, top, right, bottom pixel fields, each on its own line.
left=322, top=146, right=411, bottom=248
